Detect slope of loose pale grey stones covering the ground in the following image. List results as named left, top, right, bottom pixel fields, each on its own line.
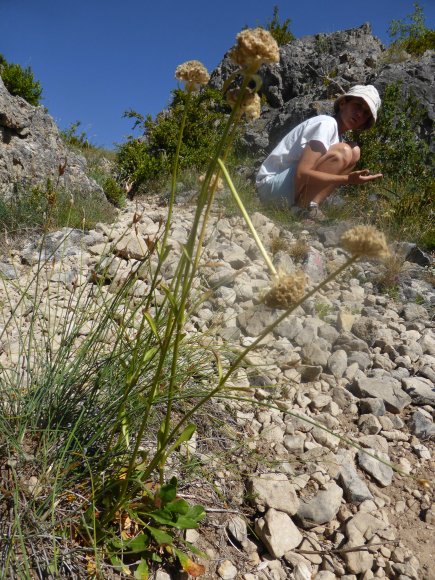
left=0, top=200, right=435, bottom=580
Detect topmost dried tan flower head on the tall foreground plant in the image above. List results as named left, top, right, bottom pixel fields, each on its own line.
left=229, top=28, right=279, bottom=72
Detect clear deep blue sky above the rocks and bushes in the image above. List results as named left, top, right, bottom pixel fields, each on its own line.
left=0, top=0, right=435, bottom=148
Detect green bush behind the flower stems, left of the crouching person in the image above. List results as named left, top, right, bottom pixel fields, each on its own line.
left=117, top=87, right=232, bottom=189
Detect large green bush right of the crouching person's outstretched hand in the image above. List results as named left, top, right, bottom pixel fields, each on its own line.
left=353, top=83, right=435, bottom=248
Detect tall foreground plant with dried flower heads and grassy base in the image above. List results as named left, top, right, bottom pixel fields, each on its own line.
left=0, top=28, right=422, bottom=578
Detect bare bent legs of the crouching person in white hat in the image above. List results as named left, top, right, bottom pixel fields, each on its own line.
left=295, top=143, right=360, bottom=207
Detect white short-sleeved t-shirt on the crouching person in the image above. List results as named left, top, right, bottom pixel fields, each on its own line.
left=256, top=115, right=340, bottom=184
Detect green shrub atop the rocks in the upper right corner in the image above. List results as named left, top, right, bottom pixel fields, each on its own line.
left=388, top=2, right=435, bottom=56
